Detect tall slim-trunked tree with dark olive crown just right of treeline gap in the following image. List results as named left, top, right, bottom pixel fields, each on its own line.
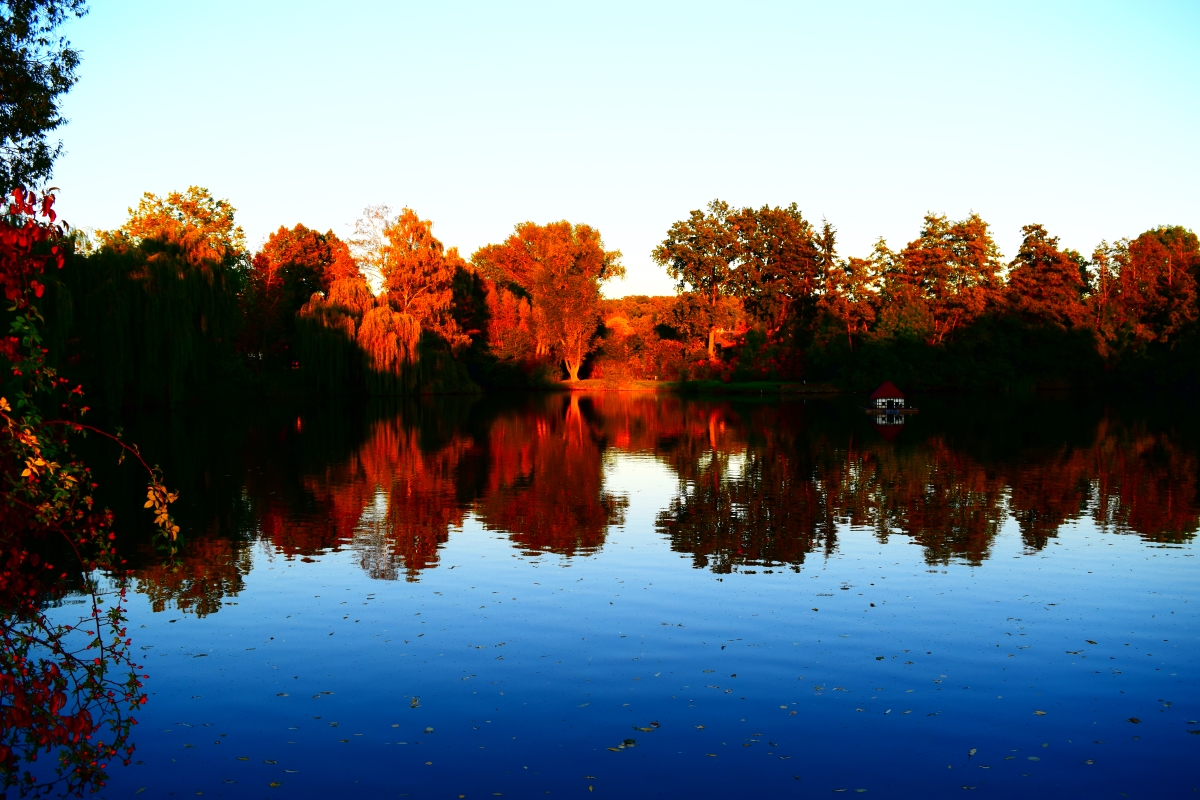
left=650, top=200, right=743, bottom=360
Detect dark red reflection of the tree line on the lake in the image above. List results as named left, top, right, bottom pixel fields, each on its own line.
left=124, top=393, right=1200, bottom=614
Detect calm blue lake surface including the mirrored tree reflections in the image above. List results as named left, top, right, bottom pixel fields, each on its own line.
left=51, top=395, right=1200, bottom=798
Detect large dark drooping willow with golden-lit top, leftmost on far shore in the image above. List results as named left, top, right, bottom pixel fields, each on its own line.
left=44, top=187, right=246, bottom=408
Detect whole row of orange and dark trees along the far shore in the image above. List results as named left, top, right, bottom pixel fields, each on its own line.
left=30, top=187, right=1200, bottom=404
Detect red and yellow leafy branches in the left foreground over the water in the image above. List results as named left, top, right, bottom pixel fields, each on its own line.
left=0, top=188, right=179, bottom=796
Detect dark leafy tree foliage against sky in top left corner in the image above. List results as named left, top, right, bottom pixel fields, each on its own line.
left=0, top=0, right=88, bottom=191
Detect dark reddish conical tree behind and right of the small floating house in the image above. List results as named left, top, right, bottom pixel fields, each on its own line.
left=1007, top=224, right=1087, bottom=327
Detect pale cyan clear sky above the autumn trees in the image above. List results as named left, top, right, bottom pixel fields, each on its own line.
left=53, top=0, right=1200, bottom=296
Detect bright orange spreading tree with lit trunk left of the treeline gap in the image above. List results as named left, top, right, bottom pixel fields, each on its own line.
left=472, top=219, right=625, bottom=380
